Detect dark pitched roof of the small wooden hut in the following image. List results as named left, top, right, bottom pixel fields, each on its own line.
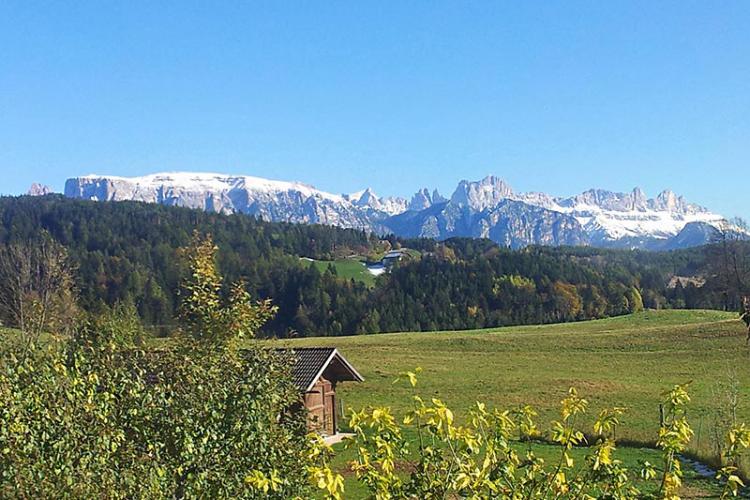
left=284, top=347, right=364, bottom=392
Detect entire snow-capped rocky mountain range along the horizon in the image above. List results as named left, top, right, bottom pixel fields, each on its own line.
left=64, top=172, right=724, bottom=250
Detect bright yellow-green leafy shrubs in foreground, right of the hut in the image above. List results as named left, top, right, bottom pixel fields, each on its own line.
left=336, top=372, right=750, bottom=499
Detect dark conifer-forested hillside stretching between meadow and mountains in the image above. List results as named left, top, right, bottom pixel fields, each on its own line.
left=0, top=195, right=740, bottom=336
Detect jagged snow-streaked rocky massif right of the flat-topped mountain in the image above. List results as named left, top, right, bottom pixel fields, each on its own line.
left=400, top=176, right=723, bottom=249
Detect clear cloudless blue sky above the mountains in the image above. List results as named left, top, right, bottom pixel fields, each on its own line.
left=0, top=0, right=750, bottom=218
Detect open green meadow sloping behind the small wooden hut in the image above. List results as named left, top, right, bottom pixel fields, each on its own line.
left=284, top=311, right=750, bottom=498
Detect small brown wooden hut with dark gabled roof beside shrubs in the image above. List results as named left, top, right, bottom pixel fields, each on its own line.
left=287, top=347, right=364, bottom=436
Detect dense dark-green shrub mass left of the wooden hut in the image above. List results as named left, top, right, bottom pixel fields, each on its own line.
left=0, top=235, right=330, bottom=499
